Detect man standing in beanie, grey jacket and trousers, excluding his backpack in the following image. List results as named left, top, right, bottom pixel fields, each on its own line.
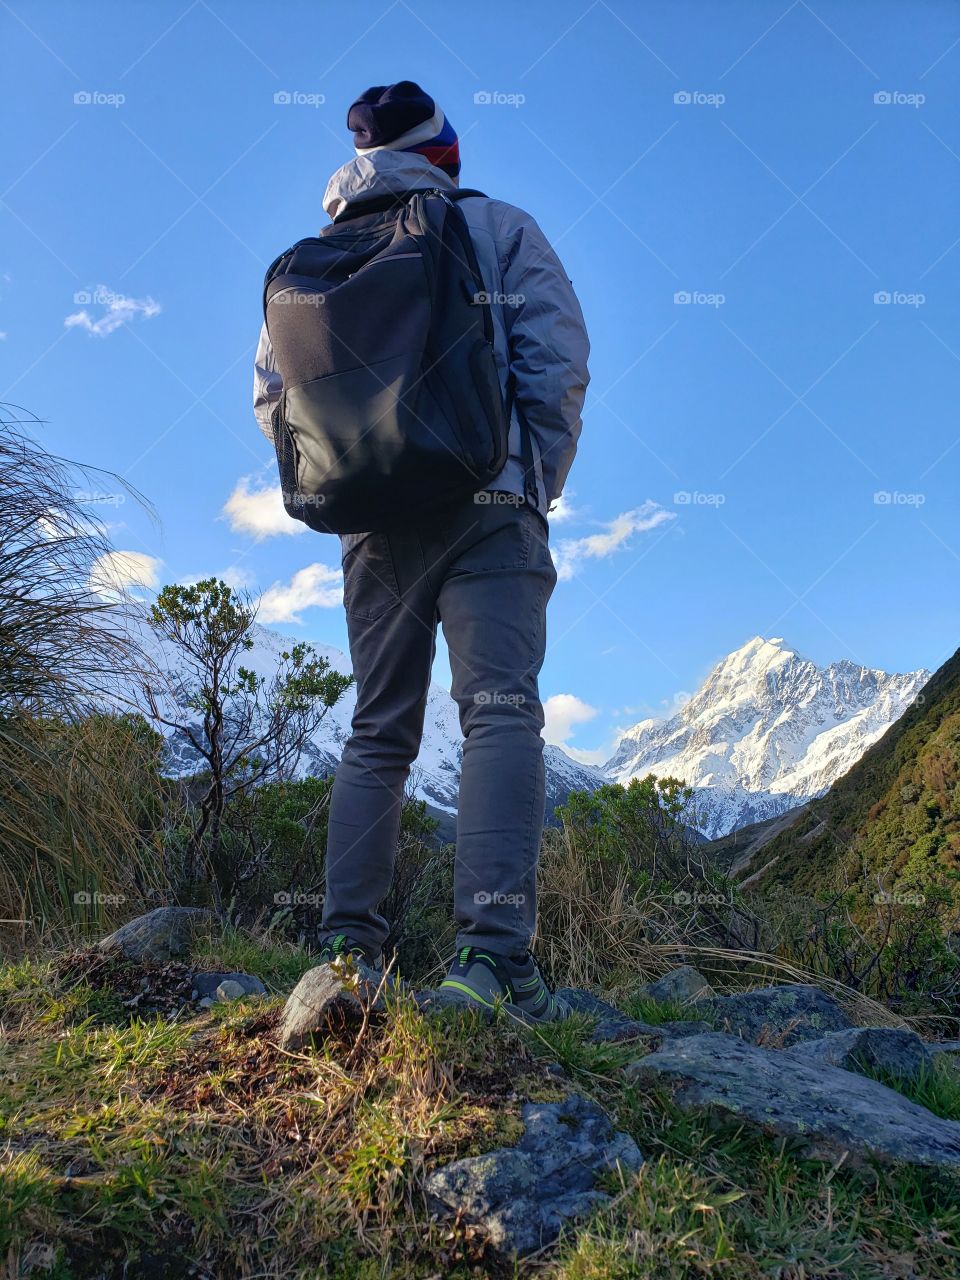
left=253, top=81, right=589, bottom=1021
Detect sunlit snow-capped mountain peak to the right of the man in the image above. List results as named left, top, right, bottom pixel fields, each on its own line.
left=603, top=636, right=929, bottom=837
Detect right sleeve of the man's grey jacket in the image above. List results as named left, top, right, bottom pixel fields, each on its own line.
left=498, top=205, right=590, bottom=503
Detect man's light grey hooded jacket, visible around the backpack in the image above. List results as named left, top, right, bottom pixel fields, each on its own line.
left=253, top=151, right=590, bottom=513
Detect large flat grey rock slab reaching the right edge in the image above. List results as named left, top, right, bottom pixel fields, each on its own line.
left=623, top=1032, right=960, bottom=1169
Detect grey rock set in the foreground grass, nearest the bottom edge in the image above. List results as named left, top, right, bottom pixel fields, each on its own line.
left=426, top=1094, right=644, bottom=1256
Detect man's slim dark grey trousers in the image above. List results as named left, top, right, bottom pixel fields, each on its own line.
left=324, top=494, right=557, bottom=955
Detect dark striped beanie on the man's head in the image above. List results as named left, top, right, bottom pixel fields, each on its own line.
left=347, top=81, right=460, bottom=178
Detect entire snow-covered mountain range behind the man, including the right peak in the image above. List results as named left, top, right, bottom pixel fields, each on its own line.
left=132, top=611, right=929, bottom=838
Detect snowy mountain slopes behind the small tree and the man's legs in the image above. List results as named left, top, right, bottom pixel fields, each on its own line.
left=128, top=611, right=607, bottom=838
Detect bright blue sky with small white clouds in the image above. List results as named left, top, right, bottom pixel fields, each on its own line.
left=0, top=0, right=960, bottom=754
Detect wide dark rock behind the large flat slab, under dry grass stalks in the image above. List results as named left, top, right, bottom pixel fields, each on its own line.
left=698, top=982, right=854, bottom=1047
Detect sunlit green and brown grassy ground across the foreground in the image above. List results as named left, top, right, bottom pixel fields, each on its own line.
left=0, top=936, right=960, bottom=1280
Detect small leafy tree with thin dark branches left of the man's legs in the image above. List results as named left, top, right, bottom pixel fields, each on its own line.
left=145, top=577, right=353, bottom=911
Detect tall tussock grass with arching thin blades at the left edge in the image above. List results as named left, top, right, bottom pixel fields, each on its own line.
left=0, top=406, right=160, bottom=955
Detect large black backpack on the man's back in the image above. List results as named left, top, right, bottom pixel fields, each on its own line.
left=264, top=191, right=536, bottom=534
